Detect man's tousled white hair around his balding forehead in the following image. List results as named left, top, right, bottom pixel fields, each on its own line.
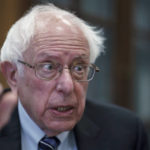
left=0, top=4, right=104, bottom=70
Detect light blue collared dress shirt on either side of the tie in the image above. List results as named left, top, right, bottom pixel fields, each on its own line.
left=18, top=101, right=77, bottom=150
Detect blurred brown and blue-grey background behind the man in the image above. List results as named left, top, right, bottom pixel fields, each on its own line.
left=0, top=0, right=150, bottom=145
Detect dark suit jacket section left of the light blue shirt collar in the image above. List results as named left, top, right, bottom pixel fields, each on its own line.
left=0, top=109, right=21, bottom=150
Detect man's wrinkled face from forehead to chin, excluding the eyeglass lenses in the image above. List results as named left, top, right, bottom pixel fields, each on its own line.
left=17, top=18, right=89, bottom=136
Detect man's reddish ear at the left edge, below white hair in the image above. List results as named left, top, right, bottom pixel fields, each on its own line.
left=0, top=61, right=17, bottom=90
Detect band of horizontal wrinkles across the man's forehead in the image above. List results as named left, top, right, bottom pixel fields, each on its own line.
left=30, top=35, right=89, bottom=52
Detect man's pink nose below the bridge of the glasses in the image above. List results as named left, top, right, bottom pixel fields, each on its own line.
left=56, top=69, right=74, bottom=95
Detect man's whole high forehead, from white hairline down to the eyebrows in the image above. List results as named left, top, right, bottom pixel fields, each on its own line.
left=25, top=16, right=89, bottom=62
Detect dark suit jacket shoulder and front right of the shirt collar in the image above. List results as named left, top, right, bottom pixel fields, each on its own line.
left=76, top=101, right=148, bottom=150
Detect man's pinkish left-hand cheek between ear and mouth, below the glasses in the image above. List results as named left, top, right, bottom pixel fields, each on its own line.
left=18, top=73, right=54, bottom=121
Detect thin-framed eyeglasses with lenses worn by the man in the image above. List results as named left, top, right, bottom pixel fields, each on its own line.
left=18, top=60, right=100, bottom=81
